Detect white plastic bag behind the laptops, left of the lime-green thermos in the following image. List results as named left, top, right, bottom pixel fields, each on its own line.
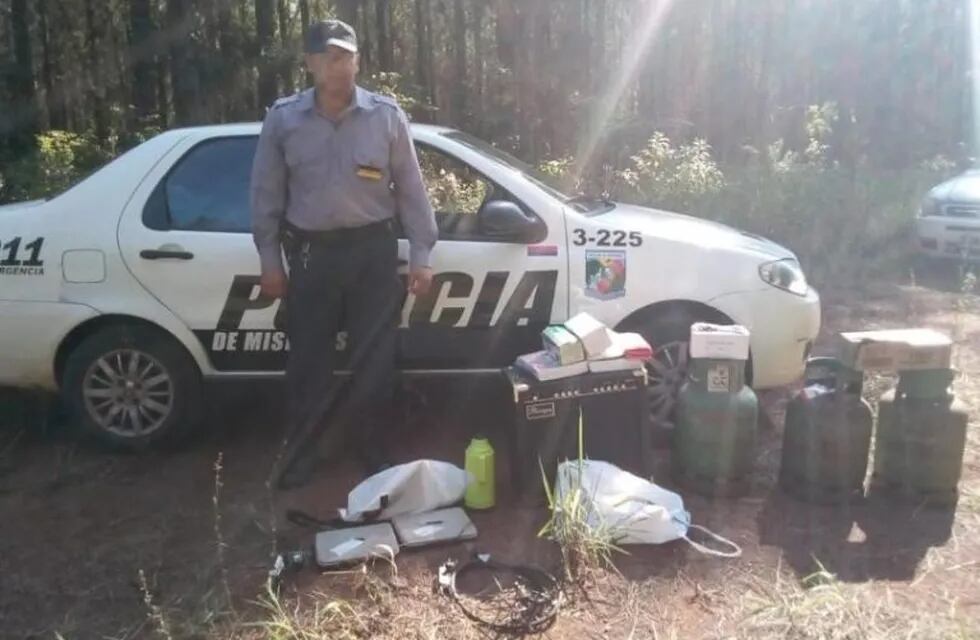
left=340, top=460, right=469, bottom=522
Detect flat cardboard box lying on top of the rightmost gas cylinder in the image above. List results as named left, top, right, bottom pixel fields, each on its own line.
left=840, top=329, right=953, bottom=371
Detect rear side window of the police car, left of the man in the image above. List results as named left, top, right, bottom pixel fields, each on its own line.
left=147, top=136, right=258, bottom=233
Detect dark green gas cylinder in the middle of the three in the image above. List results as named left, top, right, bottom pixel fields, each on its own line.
left=779, top=358, right=874, bottom=503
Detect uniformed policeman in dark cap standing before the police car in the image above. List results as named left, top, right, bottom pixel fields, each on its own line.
left=251, top=20, right=437, bottom=488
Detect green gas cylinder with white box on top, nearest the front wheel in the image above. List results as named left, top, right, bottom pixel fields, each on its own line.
left=673, top=358, right=759, bottom=496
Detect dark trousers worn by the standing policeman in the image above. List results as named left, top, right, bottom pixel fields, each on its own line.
left=283, top=222, right=405, bottom=465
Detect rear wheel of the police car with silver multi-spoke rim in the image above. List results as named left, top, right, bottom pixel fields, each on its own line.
left=63, top=326, right=201, bottom=449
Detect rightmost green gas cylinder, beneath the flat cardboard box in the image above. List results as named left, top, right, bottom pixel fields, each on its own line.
left=872, top=369, right=969, bottom=505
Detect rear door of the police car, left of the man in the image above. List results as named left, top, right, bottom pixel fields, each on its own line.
left=119, top=135, right=288, bottom=372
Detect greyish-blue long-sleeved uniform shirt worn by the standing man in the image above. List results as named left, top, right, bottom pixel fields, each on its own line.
left=251, top=87, right=438, bottom=272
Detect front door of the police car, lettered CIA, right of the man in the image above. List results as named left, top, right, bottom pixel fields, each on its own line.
left=400, top=144, right=567, bottom=369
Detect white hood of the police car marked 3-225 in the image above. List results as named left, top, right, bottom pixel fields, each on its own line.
left=601, top=203, right=796, bottom=260
